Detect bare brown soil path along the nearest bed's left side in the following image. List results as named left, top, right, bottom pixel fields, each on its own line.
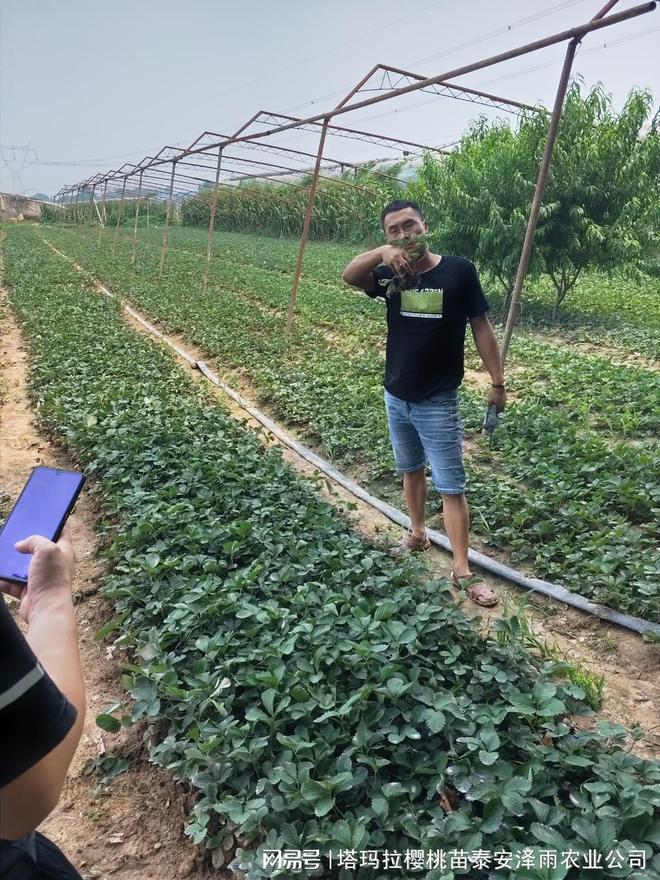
left=0, top=290, right=215, bottom=880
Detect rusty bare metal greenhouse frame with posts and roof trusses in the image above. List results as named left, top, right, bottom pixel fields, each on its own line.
left=56, top=0, right=656, bottom=348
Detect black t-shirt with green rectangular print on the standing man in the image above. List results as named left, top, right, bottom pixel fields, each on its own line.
left=369, top=256, right=489, bottom=402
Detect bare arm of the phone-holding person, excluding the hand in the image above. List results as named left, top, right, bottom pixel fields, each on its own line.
left=0, top=594, right=85, bottom=839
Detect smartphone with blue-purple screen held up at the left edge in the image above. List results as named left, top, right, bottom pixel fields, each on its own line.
left=0, top=467, right=85, bottom=584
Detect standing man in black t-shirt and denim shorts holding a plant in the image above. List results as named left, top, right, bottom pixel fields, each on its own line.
left=342, top=200, right=506, bottom=606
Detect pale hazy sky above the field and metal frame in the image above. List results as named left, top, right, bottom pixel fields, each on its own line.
left=0, top=0, right=660, bottom=194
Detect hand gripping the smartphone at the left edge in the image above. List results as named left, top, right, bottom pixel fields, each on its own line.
left=0, top=528, right=74, bottom=623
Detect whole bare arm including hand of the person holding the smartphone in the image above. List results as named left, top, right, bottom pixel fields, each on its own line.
left=0, top=533, right=85, bottom=840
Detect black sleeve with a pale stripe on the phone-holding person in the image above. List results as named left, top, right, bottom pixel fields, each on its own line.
left=0, top=595, right=78, bottom=788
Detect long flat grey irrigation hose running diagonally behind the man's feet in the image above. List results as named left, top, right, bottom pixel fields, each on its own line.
left=44, top=239, right=660, bottom=636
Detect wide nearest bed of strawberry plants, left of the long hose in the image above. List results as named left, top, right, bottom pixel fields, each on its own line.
left=5, top=228, right=660, bottom=880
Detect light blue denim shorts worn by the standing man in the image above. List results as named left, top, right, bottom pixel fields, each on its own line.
left=385, top=390, right=465, bottom=495
